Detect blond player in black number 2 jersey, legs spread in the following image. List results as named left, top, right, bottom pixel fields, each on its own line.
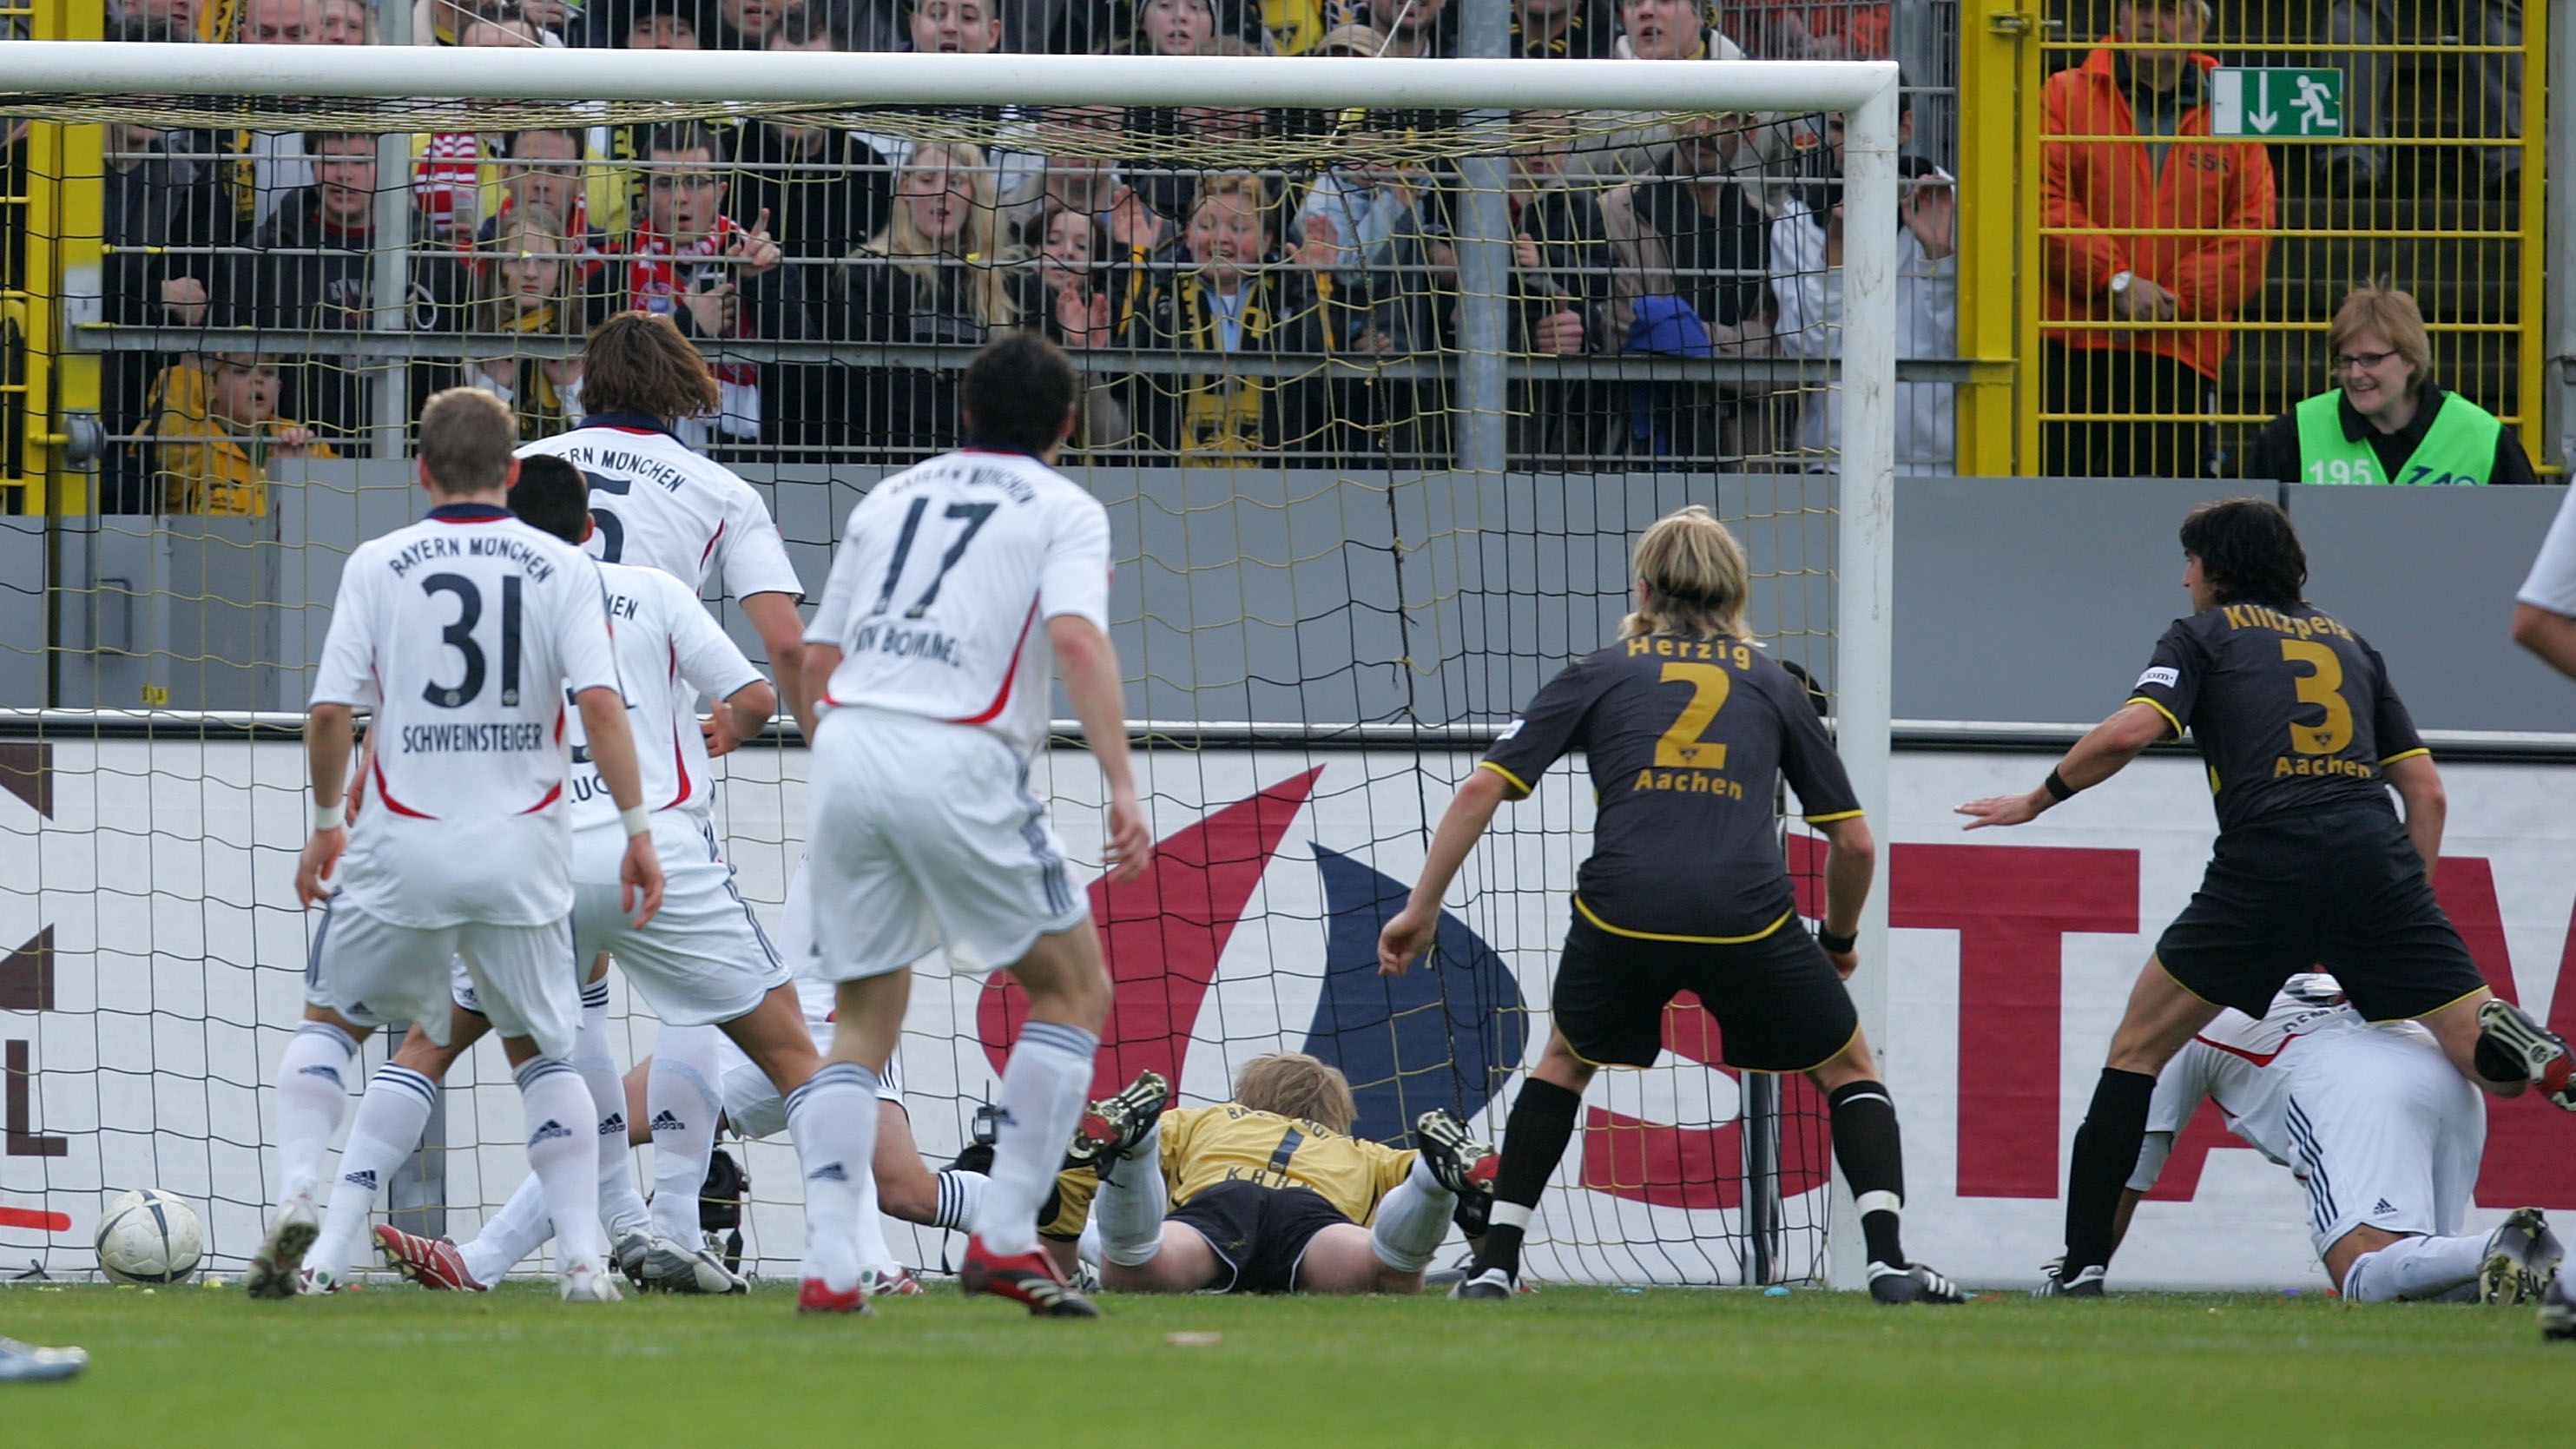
left=1378, top=504, right=1966, bottom=1302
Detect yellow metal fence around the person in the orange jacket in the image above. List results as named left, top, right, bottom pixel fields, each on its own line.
left=1958, top=0, right=2547, bottom=473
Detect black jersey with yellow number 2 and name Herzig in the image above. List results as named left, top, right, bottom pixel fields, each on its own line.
left=1484, top=633, right=1860, bottom=942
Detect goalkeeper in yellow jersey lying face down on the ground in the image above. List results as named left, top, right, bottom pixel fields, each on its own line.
left=1046, top=1052, right=1494, bottom=1292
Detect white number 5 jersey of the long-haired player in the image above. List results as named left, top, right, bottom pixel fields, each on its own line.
left=517, top=414, right=804, bottom=600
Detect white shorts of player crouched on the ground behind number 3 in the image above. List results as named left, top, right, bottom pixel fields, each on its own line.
left=2288, top=1027, right=2486, bottom=1256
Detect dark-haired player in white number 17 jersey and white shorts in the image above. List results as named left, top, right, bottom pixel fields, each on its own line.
left=799, top=332, right=1151, bottom=1318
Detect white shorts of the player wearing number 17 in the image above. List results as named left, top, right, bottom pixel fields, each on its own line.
left=804, top=705, right=1090, bottom=980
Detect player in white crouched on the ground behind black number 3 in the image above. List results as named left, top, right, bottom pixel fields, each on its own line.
left=2118, top=973, right=2560, bottom=1302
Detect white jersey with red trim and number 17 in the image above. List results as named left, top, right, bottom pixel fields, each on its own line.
left=807, top=448, right=1110, bottom=754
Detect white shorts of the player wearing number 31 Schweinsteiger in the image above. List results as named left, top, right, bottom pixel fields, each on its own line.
left=304, top=896, right=583, bottom=1057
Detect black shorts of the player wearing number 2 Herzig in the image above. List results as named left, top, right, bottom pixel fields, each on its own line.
left=1551, top=913, right=1860, bottom=1070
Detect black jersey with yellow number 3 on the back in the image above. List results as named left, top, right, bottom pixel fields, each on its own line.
left=2131, top=605, right=2427, bottom=832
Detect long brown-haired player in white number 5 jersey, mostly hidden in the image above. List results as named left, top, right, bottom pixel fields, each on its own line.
left=517, top=312, right=804, bottom=735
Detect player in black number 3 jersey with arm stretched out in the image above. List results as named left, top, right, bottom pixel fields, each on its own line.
left=1958, top=499, right=2576, bottom=1297
